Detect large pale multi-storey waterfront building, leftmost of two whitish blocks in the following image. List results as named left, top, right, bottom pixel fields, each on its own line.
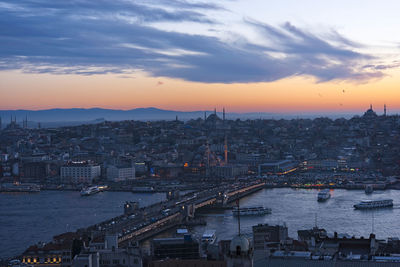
left=60, top=161, right=101, bottom=184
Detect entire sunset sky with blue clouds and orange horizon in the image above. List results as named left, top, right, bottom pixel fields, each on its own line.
left=0, top=0, right=400, bottom=114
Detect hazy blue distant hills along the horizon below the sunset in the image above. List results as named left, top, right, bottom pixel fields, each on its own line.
left=0, top=107, right=360, bottom=127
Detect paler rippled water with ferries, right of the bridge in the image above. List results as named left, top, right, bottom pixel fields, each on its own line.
left=192, top=188, right=400, bottom=244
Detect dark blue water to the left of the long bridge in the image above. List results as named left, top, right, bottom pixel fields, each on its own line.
left=0, top=191, right=165, bottom=258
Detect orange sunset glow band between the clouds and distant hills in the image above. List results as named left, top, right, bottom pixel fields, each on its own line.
left=0, top=71, right=400, bottom=113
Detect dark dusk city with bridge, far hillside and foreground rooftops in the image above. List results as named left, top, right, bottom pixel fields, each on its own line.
left=0, top=106, right=400, bottom=267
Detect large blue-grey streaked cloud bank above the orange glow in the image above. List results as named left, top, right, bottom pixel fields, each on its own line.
left=0, top=0, right=390, bottom=83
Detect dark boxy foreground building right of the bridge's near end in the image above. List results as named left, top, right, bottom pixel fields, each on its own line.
left=152, top=235, right=200, bottom=260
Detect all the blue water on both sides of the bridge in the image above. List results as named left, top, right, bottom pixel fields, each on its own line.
left=0, top=188, right=400, bottom=258
